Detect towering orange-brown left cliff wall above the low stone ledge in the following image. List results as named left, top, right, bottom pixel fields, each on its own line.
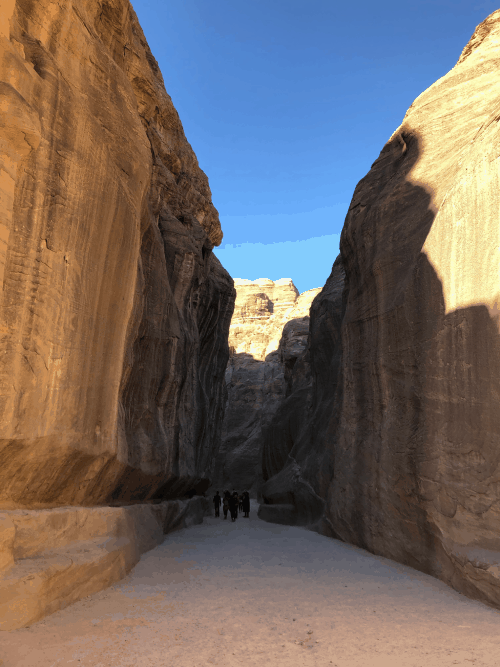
left=0, top=0, right=234, bottom=509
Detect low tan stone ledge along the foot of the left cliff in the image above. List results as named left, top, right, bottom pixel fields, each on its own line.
left=0, top=496, right=208, bottom=630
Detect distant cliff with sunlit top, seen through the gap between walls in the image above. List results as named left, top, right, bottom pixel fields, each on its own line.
left=213, top=278, right=320, bottom=497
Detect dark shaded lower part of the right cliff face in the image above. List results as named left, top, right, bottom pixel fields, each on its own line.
left=321, top=131, right=500, bottom=604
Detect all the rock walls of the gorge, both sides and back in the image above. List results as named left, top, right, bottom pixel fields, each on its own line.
left=0, top=0, right=500, bottom=630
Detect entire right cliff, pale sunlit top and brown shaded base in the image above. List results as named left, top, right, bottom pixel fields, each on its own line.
left=322, top=11, right=500, bottom=605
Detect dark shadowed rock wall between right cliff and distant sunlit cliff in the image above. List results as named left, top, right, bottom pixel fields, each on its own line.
left=259, top=257, right=344, bottom=525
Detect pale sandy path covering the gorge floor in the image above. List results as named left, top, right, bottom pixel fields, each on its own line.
left=0, top=507, right=500, bottom=667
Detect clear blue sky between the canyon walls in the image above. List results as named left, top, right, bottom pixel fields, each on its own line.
left=132, top=0, right=498, bottom=292
